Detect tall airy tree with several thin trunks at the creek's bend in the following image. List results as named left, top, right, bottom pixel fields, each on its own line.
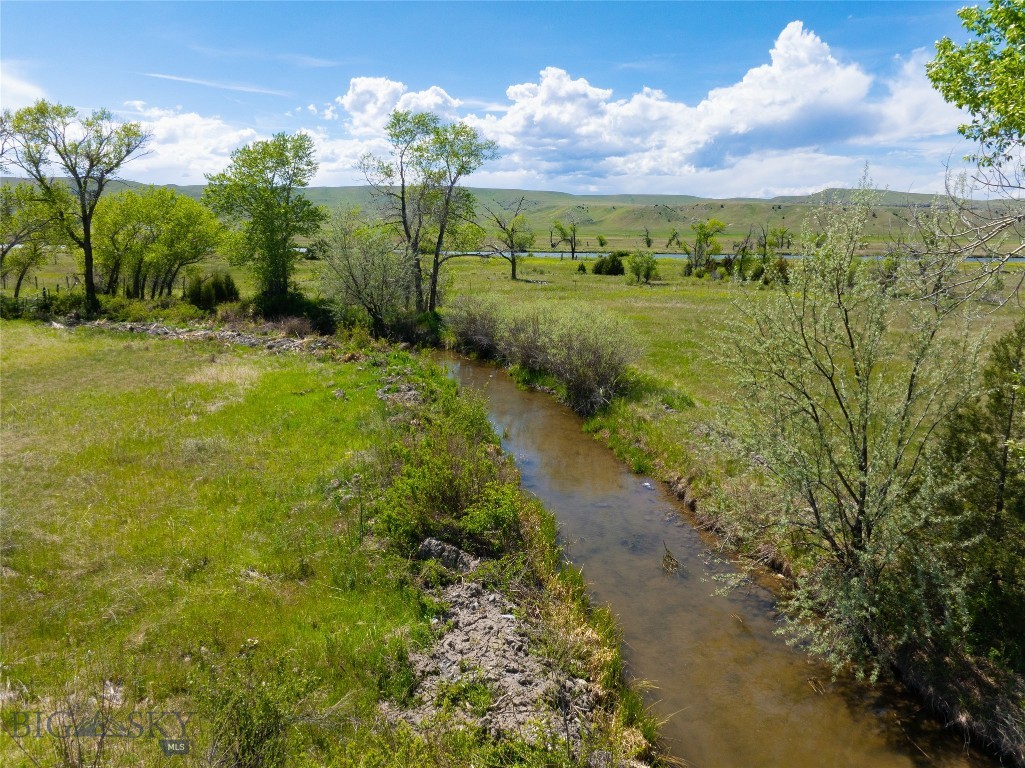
left=359, top=111, right=497, bottom=314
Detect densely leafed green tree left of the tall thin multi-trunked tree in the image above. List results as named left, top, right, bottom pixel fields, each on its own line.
left=203, top=133, right=327, bottom=305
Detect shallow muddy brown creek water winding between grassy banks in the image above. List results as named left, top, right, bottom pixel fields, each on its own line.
left=439, top=355, right=996, bottom=768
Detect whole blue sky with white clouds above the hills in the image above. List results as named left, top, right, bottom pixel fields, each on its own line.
left=0, top=0, right=972, bottom=198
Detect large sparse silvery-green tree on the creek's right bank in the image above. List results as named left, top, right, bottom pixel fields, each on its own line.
left=725, top=180, right=981, bottom=672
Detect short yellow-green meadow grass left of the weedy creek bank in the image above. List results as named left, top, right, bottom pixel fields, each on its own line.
left=0, top=322, right=431, bottom=755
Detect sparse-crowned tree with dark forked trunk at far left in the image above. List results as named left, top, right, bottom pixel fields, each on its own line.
left=3, top=99, right=150, bottom=311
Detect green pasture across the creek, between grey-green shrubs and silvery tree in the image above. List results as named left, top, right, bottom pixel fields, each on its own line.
left=443, top=251, right=1022, bottom=492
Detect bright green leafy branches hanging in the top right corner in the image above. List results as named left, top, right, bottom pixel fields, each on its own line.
left=926, top=0, right=1025, bottom=166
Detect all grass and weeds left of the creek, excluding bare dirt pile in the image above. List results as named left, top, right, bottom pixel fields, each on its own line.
left=0, top=321, right=655, bottom=766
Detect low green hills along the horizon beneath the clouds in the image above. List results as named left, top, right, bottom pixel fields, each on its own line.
left=5, top=179, right=934, bottom=250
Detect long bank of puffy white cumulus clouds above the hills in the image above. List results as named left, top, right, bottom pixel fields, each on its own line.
left=97, top=22, right=964, bottom=196
